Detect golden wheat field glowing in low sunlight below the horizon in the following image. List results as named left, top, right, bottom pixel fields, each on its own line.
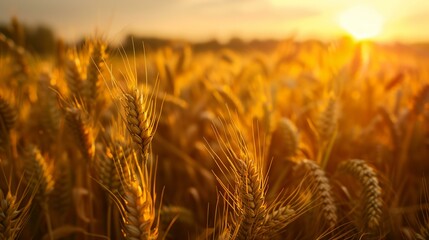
left=0, top=17, right=429, bottom=240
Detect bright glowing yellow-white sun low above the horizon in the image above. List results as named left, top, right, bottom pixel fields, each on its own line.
left=339, top=6, right=383, bottom=40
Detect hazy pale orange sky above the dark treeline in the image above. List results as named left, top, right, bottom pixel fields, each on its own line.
left=0, top=0, right=429, bottom=41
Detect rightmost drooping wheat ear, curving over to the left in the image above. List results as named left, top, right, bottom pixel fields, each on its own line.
left=339, top=159, right=383, bottom=231
